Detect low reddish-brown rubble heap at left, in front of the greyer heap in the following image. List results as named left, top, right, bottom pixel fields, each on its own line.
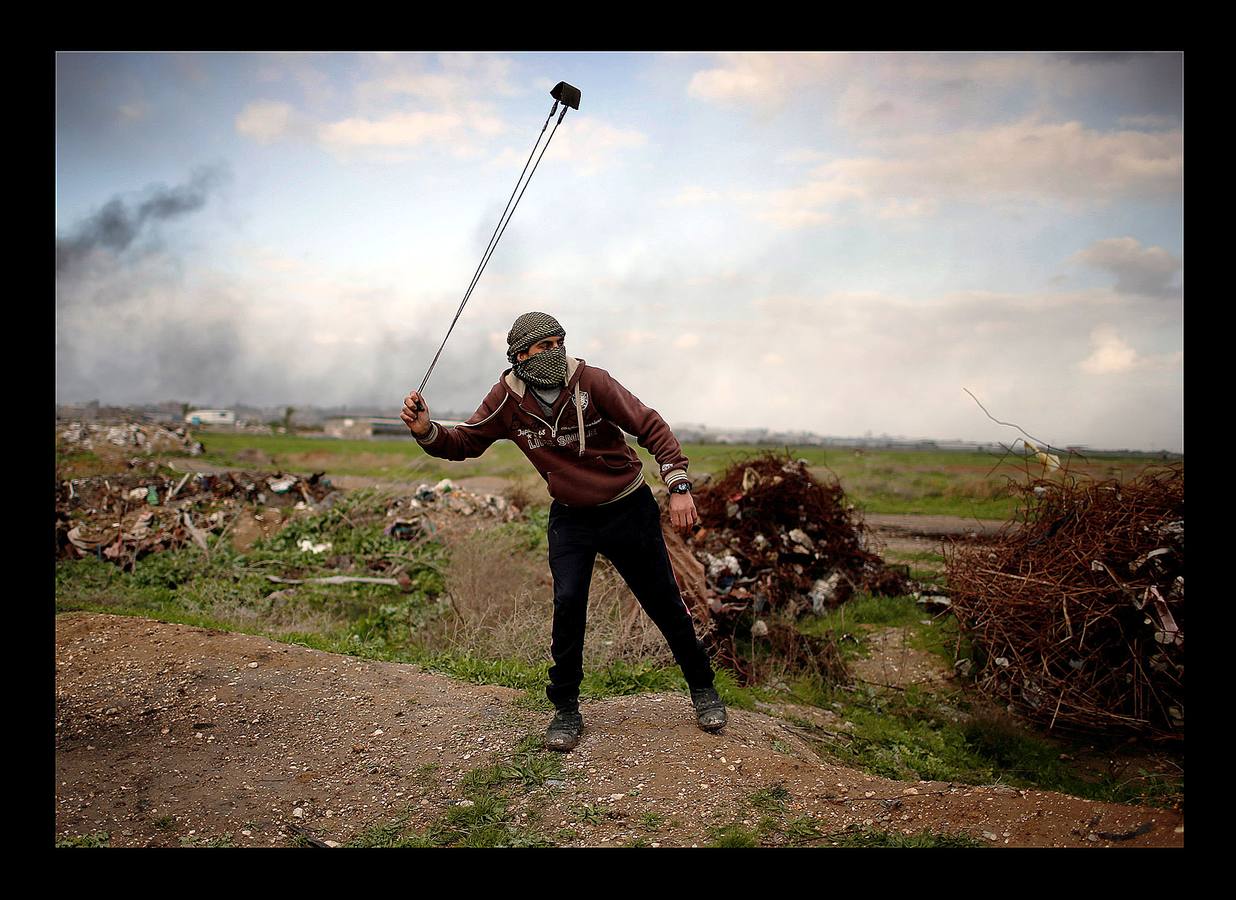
left=56, top=472, right=335, bottom=567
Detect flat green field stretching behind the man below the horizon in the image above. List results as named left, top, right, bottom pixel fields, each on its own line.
left=187, top=431, right=1171, bottom=519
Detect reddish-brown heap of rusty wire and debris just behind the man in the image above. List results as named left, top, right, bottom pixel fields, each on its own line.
left=687, top=451, right=910, bottom=681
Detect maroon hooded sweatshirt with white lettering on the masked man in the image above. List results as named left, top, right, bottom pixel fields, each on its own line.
left=417, top=356, right=687, bottom=507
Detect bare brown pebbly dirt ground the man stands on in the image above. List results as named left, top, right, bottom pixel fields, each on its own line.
left=56, top=613, right=1184, bottom=847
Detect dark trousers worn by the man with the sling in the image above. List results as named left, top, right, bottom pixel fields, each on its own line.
left=545, top=485, right=712, bottom=706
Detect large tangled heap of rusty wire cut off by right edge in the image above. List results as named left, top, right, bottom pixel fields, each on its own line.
left=946, top=465, right=1184, bottom=741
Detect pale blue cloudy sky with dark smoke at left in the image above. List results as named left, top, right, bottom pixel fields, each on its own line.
left=56, top=52, right=1184, bottom=451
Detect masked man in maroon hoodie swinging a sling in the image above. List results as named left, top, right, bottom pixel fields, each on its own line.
left=402, top=313, right=726, bottom=750
